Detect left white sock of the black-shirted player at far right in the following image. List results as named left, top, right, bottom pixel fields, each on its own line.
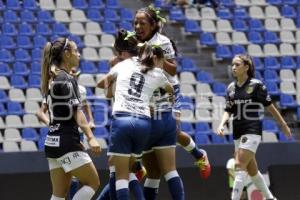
left=231, top=170, right=247, bottom=200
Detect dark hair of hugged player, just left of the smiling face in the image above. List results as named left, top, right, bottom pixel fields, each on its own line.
left=114, top=29, right=138, bottom=56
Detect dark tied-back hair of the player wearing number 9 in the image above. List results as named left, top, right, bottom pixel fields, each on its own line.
left=139, top=43, right=164, bottom=74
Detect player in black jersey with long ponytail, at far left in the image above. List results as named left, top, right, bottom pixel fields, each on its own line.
left=42, top=38, right=101, bottom=200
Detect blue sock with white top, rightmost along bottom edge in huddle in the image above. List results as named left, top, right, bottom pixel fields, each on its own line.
left=165, top=170, right=184, bottom=200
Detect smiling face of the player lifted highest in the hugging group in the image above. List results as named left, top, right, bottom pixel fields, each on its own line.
left=134, top=11, right=157, bottom=41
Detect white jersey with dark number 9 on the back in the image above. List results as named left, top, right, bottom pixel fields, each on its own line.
left=109, top=57, right=169, bottom=117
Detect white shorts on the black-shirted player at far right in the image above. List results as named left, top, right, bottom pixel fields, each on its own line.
left=234, top=134, right=261, bottom=153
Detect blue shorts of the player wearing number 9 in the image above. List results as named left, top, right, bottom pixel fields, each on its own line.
left=107, top=113, right=151, bottom=157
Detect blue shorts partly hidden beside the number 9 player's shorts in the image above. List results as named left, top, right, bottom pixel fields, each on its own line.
left=144, top=111, right=176, bottom=153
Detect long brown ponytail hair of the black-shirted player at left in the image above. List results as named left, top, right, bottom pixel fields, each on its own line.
left=41, top=38, right=71, bottom=94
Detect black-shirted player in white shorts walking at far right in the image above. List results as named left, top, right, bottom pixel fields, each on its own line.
left=217, top=55, right=291, bottom=200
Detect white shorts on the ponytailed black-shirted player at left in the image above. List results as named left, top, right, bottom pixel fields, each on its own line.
left=48, top=151, right=92, bottom=173
